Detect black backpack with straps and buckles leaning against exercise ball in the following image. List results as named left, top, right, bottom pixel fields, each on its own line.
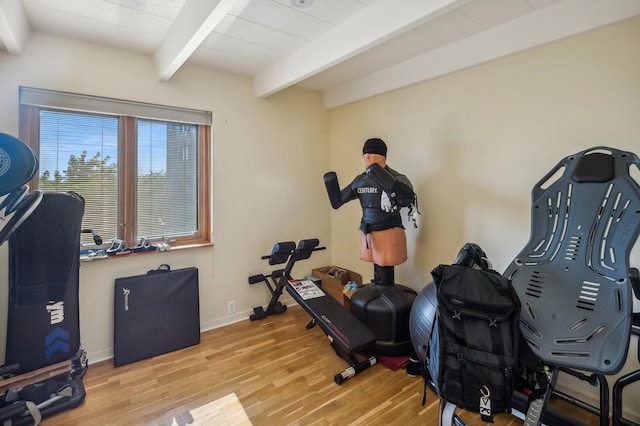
left=425, top=244, right=521, bottom=422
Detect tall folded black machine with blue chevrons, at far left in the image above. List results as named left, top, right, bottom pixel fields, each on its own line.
left=0, top=192, right=87, bottom=425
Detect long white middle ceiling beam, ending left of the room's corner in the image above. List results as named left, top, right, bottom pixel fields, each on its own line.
left=253, top=0, right=468, bottom=97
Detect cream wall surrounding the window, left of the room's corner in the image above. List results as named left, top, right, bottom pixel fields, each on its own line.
left=0, top=34, right=331, bottom=362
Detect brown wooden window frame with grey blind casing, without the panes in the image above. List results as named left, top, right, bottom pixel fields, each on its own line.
left=19, top=87, right=212, bottom=247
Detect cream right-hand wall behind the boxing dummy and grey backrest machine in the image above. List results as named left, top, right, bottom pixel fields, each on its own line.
left=329, top=19, right=640, bottom=418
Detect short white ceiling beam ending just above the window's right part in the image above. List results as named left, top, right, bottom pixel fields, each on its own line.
left=155, top=0, right=244, bottom=81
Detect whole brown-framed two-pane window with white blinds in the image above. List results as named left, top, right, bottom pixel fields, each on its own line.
left=20, top=87, right=211, bottom=246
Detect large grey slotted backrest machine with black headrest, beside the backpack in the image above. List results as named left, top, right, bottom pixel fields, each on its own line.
left=412, top=147, right=640, bottom=426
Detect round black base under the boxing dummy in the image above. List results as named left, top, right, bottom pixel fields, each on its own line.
left=351, top=283, right=416, bottom=356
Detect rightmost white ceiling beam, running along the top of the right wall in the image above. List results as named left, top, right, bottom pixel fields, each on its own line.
left=323, top=0, right=640, bottom=109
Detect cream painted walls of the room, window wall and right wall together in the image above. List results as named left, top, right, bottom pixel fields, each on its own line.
left=0, top=15, right=640, bottom=418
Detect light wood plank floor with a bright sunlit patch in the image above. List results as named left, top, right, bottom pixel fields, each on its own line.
left=42, top=307, right=597, bottom=426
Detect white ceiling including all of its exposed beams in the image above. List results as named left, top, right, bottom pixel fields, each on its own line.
left=0, top=0, right=640, bottom=108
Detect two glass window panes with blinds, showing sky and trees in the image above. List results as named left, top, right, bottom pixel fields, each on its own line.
left=38, top=110, right=199, bottom=244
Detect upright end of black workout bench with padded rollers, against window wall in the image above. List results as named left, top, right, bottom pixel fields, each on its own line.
left=249, top=238, right=325, bottom=321
